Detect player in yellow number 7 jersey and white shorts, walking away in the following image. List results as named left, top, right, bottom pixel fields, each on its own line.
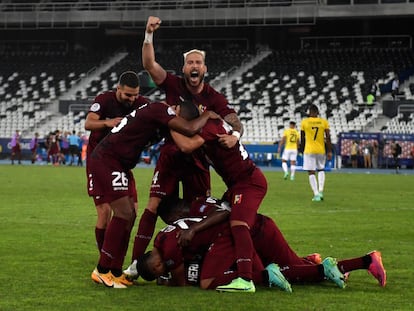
left=300, top=104, right=332, bottom=202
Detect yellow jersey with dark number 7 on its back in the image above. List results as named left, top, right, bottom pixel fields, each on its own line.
left=300, top=117, right=329, bottom=154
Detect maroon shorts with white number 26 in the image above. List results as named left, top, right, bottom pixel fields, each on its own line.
left=86, top=158, right=138, bottom=205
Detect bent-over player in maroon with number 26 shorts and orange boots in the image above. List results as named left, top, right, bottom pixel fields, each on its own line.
left=88, top=98, right=218, bottom=288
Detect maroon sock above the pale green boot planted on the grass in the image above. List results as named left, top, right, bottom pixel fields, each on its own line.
left=231, top=226, right=254, bottom=280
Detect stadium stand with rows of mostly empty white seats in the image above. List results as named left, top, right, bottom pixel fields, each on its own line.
left=0, top=42, right=414, bottom=144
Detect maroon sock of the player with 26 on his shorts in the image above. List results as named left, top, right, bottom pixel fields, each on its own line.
left=99, top=216, right=128, bottom=269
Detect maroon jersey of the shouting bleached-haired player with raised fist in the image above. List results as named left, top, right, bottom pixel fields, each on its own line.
left=159, top=73, right=236, bottom=118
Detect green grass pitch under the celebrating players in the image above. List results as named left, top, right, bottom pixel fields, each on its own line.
left=0, top=165, right=414, bottom=311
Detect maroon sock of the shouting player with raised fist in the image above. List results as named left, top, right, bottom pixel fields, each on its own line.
left=132, top=209, right=157, bottom=260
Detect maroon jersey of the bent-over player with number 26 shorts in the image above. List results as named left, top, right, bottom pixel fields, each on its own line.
left=91, top=102, right=176, bottom=170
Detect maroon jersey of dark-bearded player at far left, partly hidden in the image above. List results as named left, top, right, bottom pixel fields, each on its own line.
left=86, top=91, right=149, bottom=156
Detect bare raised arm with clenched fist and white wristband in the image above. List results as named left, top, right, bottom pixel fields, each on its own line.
left=142, top=16, right=167, bottom=85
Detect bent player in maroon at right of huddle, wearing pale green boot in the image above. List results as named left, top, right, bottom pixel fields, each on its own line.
left=172, top=103, right=267, bottom=292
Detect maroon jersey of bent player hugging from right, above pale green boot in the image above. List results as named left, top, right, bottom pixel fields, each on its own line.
left=199, top=119, right=256, bottom=187
